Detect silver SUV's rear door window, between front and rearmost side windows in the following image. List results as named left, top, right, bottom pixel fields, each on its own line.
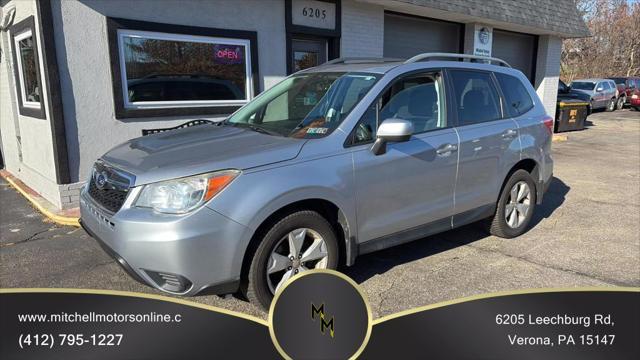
left=449, top=70, right=502, bottom=126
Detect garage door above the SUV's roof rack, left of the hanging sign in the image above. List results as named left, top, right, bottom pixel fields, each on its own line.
left=384, top=13, right=462, bottom=58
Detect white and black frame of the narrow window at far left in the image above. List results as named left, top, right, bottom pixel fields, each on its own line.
left=10, top=16, right=46, bottom=119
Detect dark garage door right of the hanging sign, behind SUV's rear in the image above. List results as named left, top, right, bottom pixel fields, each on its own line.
left=491, top=29, right=538, bottom=82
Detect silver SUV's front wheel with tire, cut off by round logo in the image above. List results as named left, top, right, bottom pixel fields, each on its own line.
left=243, top=210, right=338, bottom=310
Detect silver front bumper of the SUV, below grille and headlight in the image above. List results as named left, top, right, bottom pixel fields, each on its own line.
left=80, top=193, right=250, bottom=296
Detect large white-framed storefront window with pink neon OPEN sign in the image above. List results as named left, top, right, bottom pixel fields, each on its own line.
left=119, top=30, right=252, bottom=108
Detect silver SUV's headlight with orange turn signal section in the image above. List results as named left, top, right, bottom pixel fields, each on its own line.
left=134, top=170, right=240, bottom=214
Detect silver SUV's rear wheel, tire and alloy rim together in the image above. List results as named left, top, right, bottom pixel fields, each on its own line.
left=489, top=169, right=537, bottom=239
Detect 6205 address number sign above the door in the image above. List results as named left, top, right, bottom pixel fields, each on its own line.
left=291, top=0, right=336, bottom=30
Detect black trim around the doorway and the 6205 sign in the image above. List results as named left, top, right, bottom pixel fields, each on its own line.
left=284, top=0, right=342, bottom=75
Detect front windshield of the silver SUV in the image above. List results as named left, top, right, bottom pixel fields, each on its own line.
left=225, top=73, right=380, bottom=139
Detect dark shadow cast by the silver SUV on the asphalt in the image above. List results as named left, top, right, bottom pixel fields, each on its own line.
left=341, top=177, right=570, bottom=283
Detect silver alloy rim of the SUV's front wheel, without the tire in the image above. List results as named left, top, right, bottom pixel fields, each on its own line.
left=266, top=228, right=329, bottom=294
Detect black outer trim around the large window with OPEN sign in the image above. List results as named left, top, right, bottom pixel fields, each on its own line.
left=106, top=17, right=260, bottom=119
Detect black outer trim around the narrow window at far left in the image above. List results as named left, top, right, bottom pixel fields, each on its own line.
left=9, top=15, right=47, bottom=119
